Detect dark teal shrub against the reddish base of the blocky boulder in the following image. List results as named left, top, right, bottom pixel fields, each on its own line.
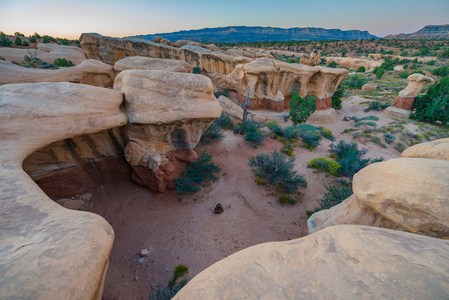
left=175, top=152, right=221, bottom=195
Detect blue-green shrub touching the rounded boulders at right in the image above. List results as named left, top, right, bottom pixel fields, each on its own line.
left=330, top=140, right=383, bottom=180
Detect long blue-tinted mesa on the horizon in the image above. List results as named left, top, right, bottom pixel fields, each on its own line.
left=138, top=26, right=377, bottom=43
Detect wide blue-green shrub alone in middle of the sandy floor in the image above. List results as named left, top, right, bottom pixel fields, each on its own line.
left=248, top=150, right=307, bottom=194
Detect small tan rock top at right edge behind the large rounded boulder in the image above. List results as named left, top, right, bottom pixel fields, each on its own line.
left=401, top=138, right=449, bottom=162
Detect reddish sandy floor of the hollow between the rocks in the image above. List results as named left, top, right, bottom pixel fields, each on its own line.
left=79, top=96, right=400, bottom=300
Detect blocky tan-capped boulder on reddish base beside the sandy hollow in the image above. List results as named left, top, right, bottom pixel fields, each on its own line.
left=114, top=70, right=222, bottom=192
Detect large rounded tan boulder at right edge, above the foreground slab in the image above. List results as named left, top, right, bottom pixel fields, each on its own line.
left=353, top=158, right=449, bottom=239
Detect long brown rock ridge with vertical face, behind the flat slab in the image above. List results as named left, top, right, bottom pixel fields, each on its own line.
left=80, top=33, right=252, bottom=74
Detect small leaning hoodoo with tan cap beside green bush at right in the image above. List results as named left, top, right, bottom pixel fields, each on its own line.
left=384, top=74, right=435, bottom=119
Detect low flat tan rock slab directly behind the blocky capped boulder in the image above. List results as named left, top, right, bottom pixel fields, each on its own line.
left=114, top=56, right=193, bottom=74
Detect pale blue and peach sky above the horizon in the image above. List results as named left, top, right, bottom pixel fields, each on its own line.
left=0, top=0, right=449, bottom=39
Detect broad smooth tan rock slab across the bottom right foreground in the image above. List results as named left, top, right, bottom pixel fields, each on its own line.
left=174, top=225, right=449, bottom=299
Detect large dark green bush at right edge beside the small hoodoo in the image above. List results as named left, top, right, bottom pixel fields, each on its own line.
left=410, top=77, right=449, bottom=124
